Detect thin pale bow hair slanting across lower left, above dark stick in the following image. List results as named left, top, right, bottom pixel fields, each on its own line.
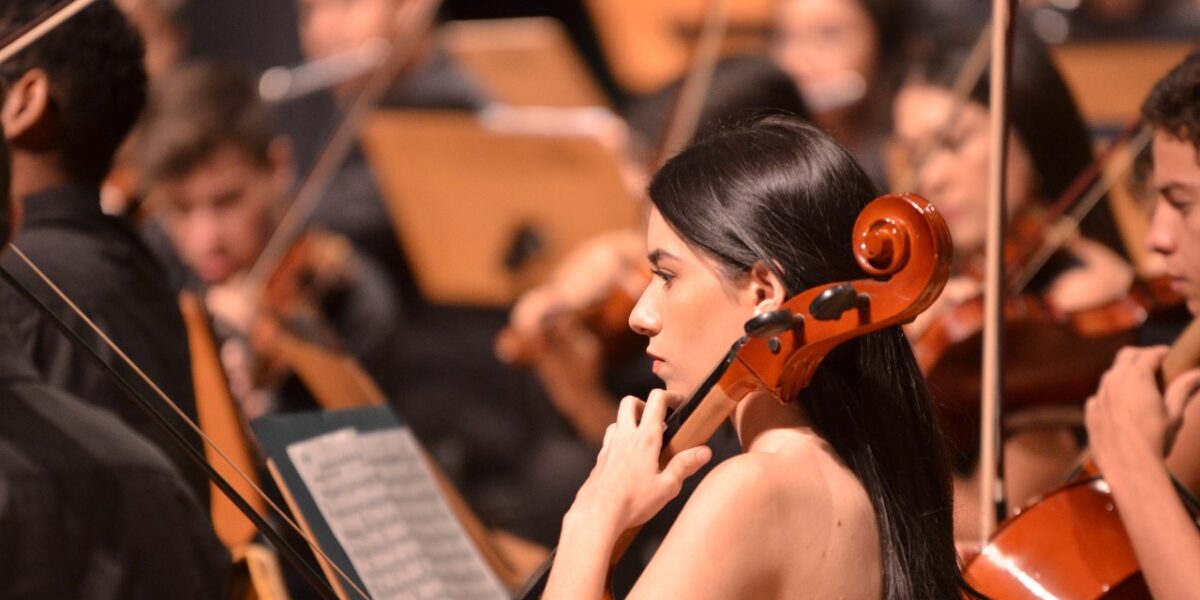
left=8, top=244, right=370, bottom=598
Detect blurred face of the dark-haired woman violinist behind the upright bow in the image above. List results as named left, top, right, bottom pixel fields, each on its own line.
left=894, top=85, right=1037, bottom=256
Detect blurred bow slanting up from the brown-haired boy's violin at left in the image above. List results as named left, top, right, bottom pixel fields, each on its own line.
left=244, top=0, right=440, bottom=298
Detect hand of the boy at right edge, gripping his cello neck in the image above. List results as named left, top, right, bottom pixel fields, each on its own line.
left=1086, top=346, right=1200, bottom=475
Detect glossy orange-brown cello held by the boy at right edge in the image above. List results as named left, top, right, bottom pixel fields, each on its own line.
left=964, top=319, right=1200, bottom=600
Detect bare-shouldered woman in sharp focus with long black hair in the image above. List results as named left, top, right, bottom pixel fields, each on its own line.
left=545, top=116, right=962, bottom=599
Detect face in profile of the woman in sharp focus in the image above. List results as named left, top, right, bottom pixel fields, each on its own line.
left=629, top=210, right=757, bottom=395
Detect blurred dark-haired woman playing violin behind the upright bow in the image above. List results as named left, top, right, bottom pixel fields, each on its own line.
left=895, top=31, right=1133, bottom=538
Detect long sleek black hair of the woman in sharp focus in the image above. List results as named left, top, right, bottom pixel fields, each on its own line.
left=649, top=115, right=964, bottom=600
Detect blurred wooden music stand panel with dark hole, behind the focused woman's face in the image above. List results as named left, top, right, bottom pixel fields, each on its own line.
left=362, top=110, right=642, bottom=306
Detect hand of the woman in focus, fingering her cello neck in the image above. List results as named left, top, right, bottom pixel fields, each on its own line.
left=568, top=390, right=713, bottom=532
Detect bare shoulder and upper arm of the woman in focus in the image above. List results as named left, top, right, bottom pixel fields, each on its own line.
left=637, top=449, right=869, bottom=598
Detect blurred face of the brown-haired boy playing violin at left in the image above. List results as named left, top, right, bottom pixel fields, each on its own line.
left=151, top=144, right=284, bottom=284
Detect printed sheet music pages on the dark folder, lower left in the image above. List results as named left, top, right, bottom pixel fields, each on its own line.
left=288, top=427, right=508, bottom=600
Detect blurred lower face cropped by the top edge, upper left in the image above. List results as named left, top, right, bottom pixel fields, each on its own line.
left=296, top=0, right=408, bottom=59
